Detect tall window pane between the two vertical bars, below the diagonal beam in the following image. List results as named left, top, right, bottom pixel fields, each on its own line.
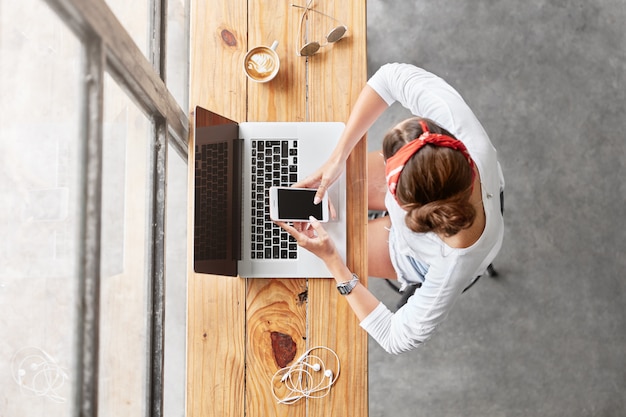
left=98, top=75, right=153, bottom=416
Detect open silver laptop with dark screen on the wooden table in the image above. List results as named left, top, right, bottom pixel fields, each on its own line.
left=193, top=107, right=346, bottom=278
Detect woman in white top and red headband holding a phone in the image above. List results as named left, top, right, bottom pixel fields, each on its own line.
left=280, top=64, right=504, bottom=353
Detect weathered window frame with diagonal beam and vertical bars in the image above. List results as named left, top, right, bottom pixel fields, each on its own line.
left=40, top=0, right=189, bottom=417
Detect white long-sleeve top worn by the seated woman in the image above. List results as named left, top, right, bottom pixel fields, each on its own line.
left=361, top=63, right=504, bottom=354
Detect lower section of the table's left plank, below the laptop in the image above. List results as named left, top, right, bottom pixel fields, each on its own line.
left=187, top=272, right=245, bottom=417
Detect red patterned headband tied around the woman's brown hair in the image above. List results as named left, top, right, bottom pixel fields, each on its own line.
left=385, top=120, right=475, bottom=200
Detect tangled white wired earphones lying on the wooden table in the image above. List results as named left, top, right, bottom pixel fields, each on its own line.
left=272, top=346, right=340, bottom=404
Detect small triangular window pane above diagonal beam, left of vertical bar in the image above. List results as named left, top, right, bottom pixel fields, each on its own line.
left=106, top=0, right=151, bottom=60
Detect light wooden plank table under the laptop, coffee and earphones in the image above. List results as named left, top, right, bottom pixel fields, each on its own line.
left=187, top=0, right=368, bottom=417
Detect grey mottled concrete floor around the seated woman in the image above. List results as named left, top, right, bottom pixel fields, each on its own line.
left=368, top=0, right=626, bottom=417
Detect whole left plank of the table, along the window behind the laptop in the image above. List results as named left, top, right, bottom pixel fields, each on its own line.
left=186, top=0, right=247, bottom=417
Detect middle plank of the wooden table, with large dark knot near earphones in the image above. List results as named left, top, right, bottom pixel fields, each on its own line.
left=246, top=0, right=307, bottom=417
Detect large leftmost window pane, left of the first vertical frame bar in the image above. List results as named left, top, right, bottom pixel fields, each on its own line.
left=0, top=0, right=83, bottom=417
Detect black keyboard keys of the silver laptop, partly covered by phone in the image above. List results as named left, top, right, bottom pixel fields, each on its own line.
left=250, top=139, right=298, bottom=259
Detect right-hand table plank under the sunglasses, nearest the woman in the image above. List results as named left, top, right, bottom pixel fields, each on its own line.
left=309, top=0, right=368, bottom=417
